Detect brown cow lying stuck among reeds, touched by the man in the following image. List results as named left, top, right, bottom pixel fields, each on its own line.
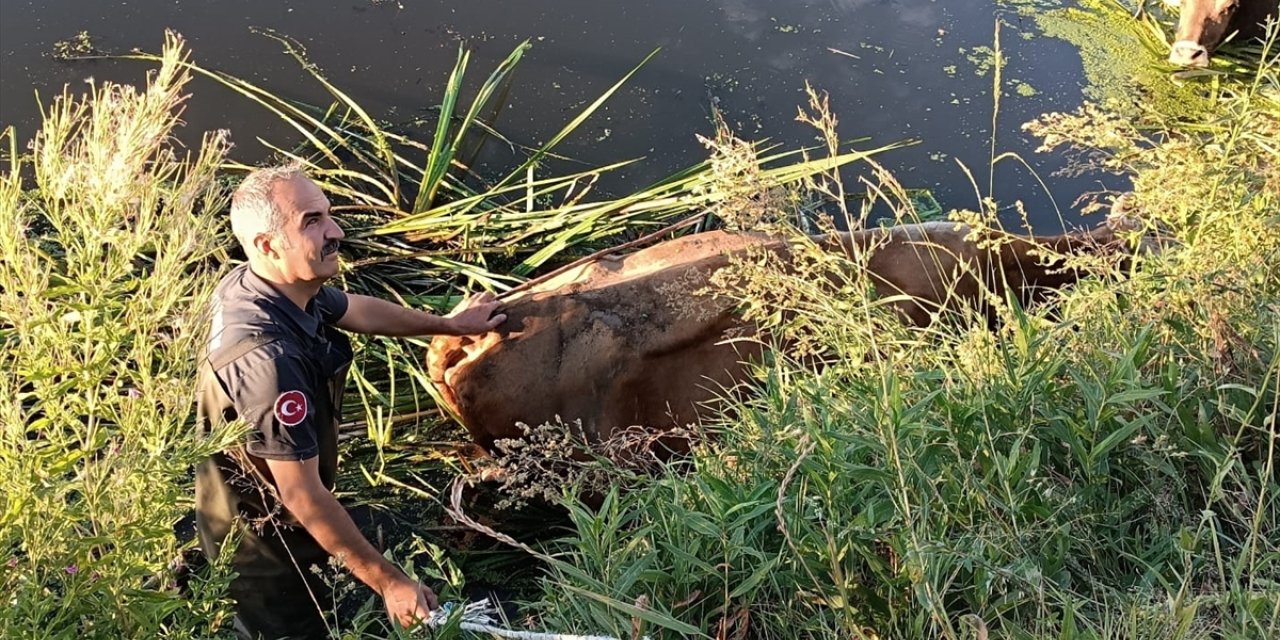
left=428, top=223, right=1119, bottom=449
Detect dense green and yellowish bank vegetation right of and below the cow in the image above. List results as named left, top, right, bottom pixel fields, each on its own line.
left=522, top=24, right=1280, bottom=639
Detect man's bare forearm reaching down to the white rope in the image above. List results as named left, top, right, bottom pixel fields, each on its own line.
left=266, top=458, right=436, bottom=627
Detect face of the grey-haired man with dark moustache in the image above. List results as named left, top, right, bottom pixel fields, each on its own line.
left=268, top=178, right=344, bottom=283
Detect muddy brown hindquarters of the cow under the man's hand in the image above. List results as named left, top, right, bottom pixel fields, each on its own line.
left=429, top=232, right=785, bottom=448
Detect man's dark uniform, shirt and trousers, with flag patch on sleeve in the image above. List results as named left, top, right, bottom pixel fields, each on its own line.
left=196, top=265, right=352, bottom=637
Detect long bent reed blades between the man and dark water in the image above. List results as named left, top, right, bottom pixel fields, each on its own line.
left=117, top=27, right=895, bottom=455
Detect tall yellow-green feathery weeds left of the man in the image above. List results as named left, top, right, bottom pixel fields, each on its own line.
left=0, top=32, right=237, bottom=639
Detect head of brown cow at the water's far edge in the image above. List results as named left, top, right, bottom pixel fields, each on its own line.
left=1165, top=0, right=1280, bottom=67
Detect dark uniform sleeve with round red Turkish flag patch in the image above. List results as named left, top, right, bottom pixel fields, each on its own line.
left=224, top=353, right=321, bottom=460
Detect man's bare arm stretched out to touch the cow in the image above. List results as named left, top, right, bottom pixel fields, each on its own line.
left=337, top=293, right=507, bottom=337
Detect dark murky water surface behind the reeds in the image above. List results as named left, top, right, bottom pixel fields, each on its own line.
left=0, top=0, right=1124, bottom=232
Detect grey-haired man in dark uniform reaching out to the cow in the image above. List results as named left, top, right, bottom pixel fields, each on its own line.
left=196, top=168, right=506, bottom=640
